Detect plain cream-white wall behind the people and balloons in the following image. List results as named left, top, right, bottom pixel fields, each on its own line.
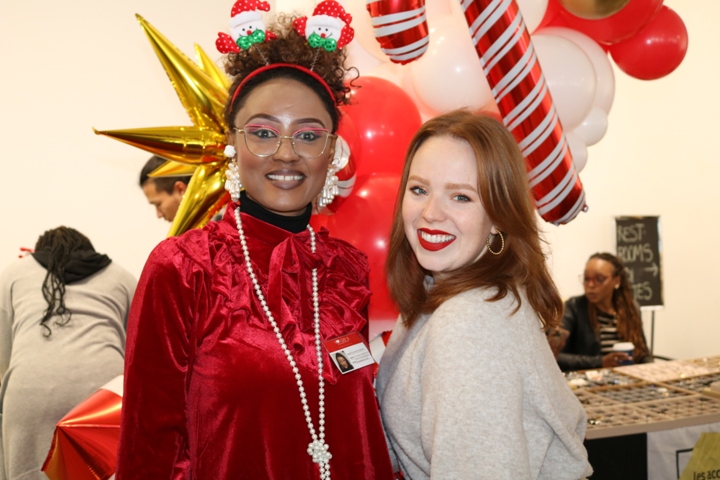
left=0, top=0, right=720, bottom=358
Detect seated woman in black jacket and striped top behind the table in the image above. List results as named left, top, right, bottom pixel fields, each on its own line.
left=558, top=253, right=653, bottom=371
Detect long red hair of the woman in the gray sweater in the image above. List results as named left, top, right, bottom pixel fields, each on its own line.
left=385, top=110, right=563, bottom=328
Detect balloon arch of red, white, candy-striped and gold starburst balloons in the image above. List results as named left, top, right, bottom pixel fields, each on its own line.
left=97, top=0, right=687, bottom=320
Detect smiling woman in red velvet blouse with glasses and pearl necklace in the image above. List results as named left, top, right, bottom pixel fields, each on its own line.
left=117, top=2, right=392, bottom=480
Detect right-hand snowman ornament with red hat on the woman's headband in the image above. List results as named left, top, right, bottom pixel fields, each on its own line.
left=293, top=0, right=355, bottom=52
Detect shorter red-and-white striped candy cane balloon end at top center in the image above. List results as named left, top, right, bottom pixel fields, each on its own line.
left=367, top=0, right=430, bottom=65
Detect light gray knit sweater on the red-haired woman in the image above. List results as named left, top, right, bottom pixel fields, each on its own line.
left=377, top=289, right=592, bottom=480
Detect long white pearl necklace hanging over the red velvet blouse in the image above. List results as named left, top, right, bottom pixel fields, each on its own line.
left=235, top=207, right=332, bottom=480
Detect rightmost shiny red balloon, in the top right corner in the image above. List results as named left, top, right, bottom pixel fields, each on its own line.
left=610, top=5, right=688, bottom=80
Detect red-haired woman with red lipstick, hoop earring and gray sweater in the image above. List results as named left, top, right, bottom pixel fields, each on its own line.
left=377, top=110, right=591, bottom=480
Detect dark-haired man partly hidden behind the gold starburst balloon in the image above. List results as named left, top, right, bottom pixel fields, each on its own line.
left=140, top=155, right=191, bottom=222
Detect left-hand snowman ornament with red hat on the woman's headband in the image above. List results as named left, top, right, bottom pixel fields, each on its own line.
left=215, top=0, right=276, bottom=53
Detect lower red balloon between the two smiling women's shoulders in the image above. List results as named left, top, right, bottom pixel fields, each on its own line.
left=324, top=173, right=400, bottom=320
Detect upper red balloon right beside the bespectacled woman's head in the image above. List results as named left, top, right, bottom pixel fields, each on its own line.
left=342, top=76, right=422, bottom=177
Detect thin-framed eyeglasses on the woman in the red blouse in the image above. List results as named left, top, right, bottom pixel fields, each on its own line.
left=234, top=124, right=337, bottom=160
